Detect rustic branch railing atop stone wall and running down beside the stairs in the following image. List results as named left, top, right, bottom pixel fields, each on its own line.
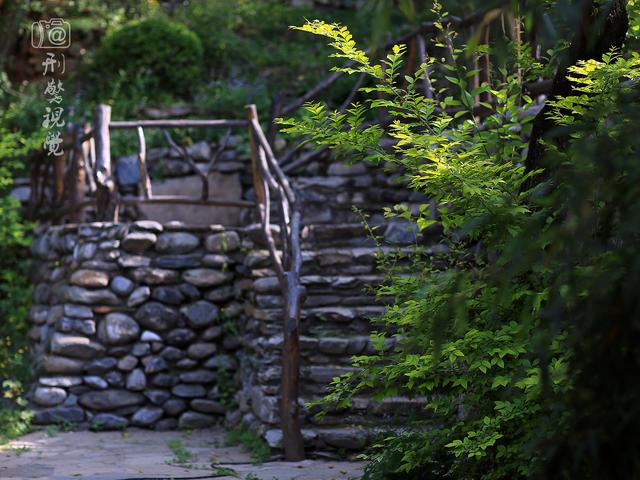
left=55, top=105, right=305, bottom=460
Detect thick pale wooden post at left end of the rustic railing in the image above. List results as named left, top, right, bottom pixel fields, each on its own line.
left=93, top=104, right=118, bottom=222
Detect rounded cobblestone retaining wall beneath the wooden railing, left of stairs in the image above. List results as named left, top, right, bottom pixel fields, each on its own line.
left=30, top=221, right=244, bottom=429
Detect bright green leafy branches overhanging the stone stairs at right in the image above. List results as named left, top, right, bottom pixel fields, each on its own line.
left=280, top=12, right=640, bottom=480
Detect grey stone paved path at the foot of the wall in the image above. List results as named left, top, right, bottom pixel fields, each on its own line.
left=0, top=429, right=362, bottom=480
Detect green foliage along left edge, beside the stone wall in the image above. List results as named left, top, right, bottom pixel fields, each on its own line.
left=0, top=74, right=35, bottom=440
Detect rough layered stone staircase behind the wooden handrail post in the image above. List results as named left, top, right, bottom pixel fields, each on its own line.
left=240, top=170, right=442, bottom=450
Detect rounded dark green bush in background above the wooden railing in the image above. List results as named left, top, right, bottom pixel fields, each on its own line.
left=92, top=17, right=203, bottom=100
